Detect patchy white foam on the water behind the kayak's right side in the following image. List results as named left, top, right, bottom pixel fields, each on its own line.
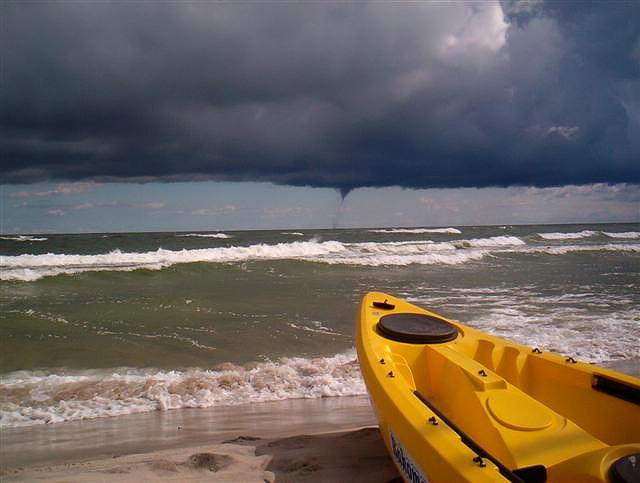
left=408, top=285, right=640, bottom=363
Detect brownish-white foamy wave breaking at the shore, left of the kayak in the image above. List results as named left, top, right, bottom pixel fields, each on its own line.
left=0, top=350, right=366, bottom=427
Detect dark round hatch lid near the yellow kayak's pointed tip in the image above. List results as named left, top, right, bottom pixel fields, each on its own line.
left=378, top=314, right=458, bottom=344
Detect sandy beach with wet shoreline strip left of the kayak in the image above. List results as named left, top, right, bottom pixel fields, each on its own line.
left=0, top=397, right=398, bottom=482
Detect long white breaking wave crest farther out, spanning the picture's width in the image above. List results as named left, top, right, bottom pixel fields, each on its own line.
left=0, top=236, right=640, bottom=282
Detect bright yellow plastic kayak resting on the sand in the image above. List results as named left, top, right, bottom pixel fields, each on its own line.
left=356, top=292, right=640, bottom=483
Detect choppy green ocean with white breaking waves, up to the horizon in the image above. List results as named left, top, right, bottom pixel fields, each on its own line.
left=0, top=224, right=640, bottom=427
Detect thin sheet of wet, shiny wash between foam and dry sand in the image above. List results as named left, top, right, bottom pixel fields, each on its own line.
left=0, top=396, right=377, bottom=468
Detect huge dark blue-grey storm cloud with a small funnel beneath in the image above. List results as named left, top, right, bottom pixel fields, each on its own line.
left=0, top=1, right=640, bottom=193
